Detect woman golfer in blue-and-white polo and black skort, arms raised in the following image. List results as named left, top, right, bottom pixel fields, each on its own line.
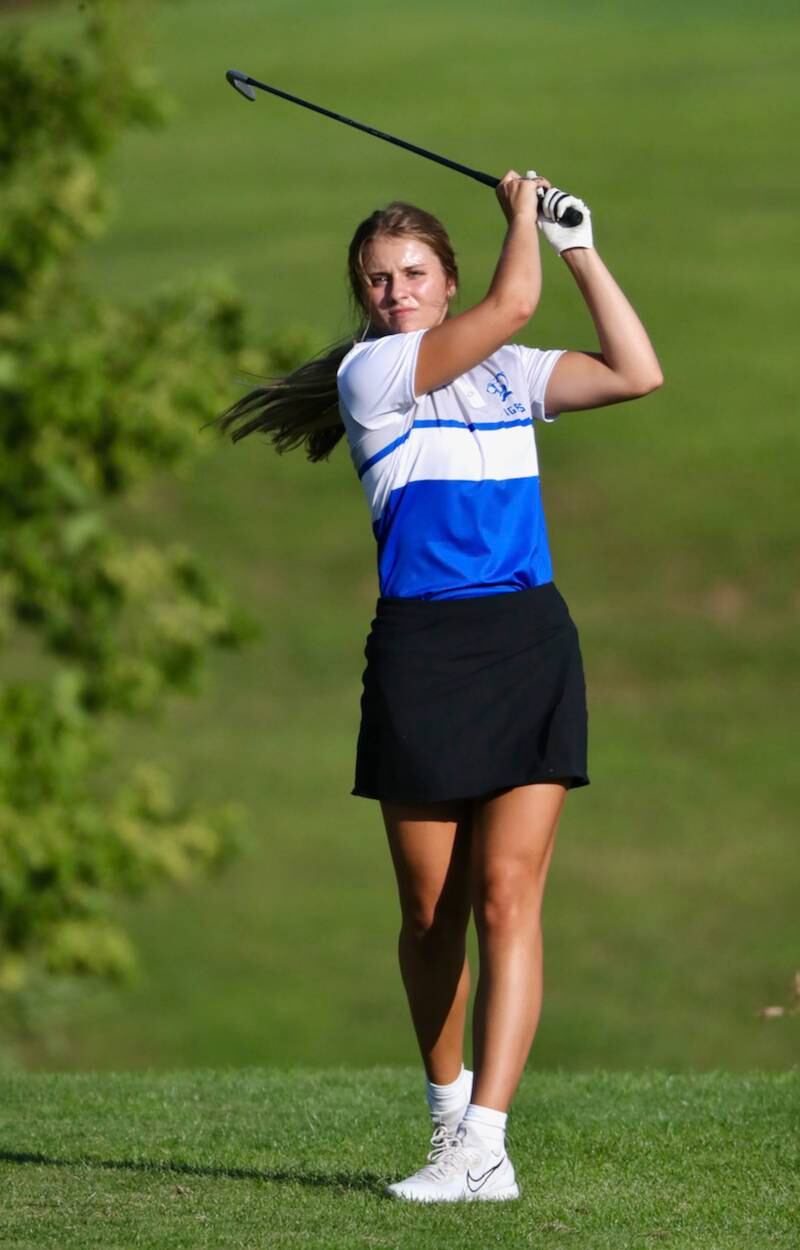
left=219, top=170, right=661, bottom=1203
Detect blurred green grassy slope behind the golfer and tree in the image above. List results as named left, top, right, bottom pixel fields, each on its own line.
left=4, top=0, right=800, bottom=1070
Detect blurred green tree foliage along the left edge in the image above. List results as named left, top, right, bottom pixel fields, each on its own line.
left=0, top=0, right=275, bottom=991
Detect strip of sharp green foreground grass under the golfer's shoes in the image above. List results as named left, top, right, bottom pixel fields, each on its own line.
left=0, top=1068, right=800, bottom=1250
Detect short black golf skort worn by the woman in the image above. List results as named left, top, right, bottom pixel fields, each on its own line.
left=351, top=581, right=589, bottom=803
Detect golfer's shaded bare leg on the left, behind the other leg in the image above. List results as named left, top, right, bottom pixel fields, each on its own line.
left=381, top=803, right=470, bottom=1085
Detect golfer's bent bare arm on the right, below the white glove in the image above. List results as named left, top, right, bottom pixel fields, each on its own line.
left=543, top=205, right=664, bottom=413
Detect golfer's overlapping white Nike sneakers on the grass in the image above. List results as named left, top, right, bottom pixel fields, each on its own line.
left=385, top=1124, right=520, bottom=1203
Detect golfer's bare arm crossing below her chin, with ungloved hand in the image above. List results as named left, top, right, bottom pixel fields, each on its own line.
left=414, top=170, right=550, bottom=395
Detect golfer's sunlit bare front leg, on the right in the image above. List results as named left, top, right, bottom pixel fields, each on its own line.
left=473, top=783, right=566, bottom=1111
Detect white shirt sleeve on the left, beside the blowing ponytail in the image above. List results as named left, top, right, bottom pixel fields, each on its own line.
left=336, top=330, right=425, bottom=430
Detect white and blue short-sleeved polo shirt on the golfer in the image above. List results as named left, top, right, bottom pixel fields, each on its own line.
left=338, top=330, right=563, bottom=599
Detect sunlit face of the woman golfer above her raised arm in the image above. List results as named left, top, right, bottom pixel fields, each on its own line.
left=364, top=235, right=455, bottom=334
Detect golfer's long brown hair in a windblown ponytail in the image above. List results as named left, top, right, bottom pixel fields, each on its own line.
left=210, top=200, right=459, bottom=461
